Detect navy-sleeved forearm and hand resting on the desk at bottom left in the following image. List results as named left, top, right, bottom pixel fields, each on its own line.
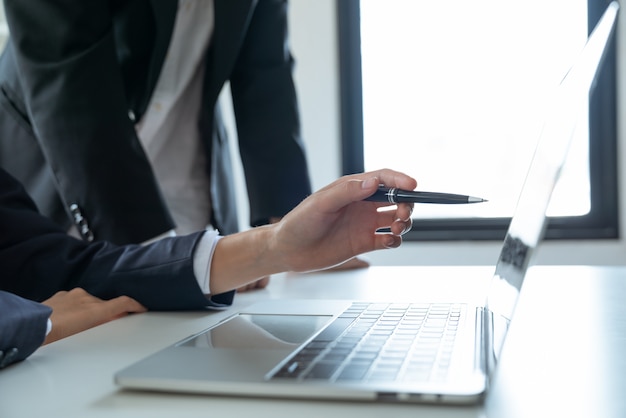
left=0, top=288, right=145, bottom=369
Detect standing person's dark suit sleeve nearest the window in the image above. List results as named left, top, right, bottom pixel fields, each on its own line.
left=228, top=0, right=311, bottom=226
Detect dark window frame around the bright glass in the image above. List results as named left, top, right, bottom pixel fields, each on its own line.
left=337, top=0, right=619, bottom=241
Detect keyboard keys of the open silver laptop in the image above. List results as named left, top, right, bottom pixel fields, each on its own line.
left=271, top=303, right=465, bottom=382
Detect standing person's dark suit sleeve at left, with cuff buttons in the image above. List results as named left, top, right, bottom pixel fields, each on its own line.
left=4, top=0, right=173, bottom=244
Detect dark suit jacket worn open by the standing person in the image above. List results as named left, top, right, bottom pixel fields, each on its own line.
left=0, top=0, right=310, bottom=244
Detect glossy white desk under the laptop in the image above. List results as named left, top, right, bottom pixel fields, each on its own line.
left=0, top=267, right=626, bottom=418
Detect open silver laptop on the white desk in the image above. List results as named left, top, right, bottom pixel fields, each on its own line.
left=115, top=2, right=618, bottom=404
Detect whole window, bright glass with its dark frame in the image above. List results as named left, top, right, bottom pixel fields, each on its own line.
left=338, top=0, right=618, bottom=240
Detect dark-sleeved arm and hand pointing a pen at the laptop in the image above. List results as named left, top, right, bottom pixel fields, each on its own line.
left=0, top=165, right=417, bottom=310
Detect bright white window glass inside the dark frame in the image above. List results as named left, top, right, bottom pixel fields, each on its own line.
left=360, top=0, right=590, bottom=218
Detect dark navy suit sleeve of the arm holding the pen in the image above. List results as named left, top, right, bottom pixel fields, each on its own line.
left=0, top=169, right=234, bottom=310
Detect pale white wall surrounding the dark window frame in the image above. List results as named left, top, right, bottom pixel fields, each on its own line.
left=276, top=0, right=626, bottom=265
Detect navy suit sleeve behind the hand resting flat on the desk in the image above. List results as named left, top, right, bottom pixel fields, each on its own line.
left=0, top=291, right=52, bottom=369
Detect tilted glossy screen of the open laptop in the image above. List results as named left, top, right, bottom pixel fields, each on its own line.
left=486, top=2, right=619, bottom=320
